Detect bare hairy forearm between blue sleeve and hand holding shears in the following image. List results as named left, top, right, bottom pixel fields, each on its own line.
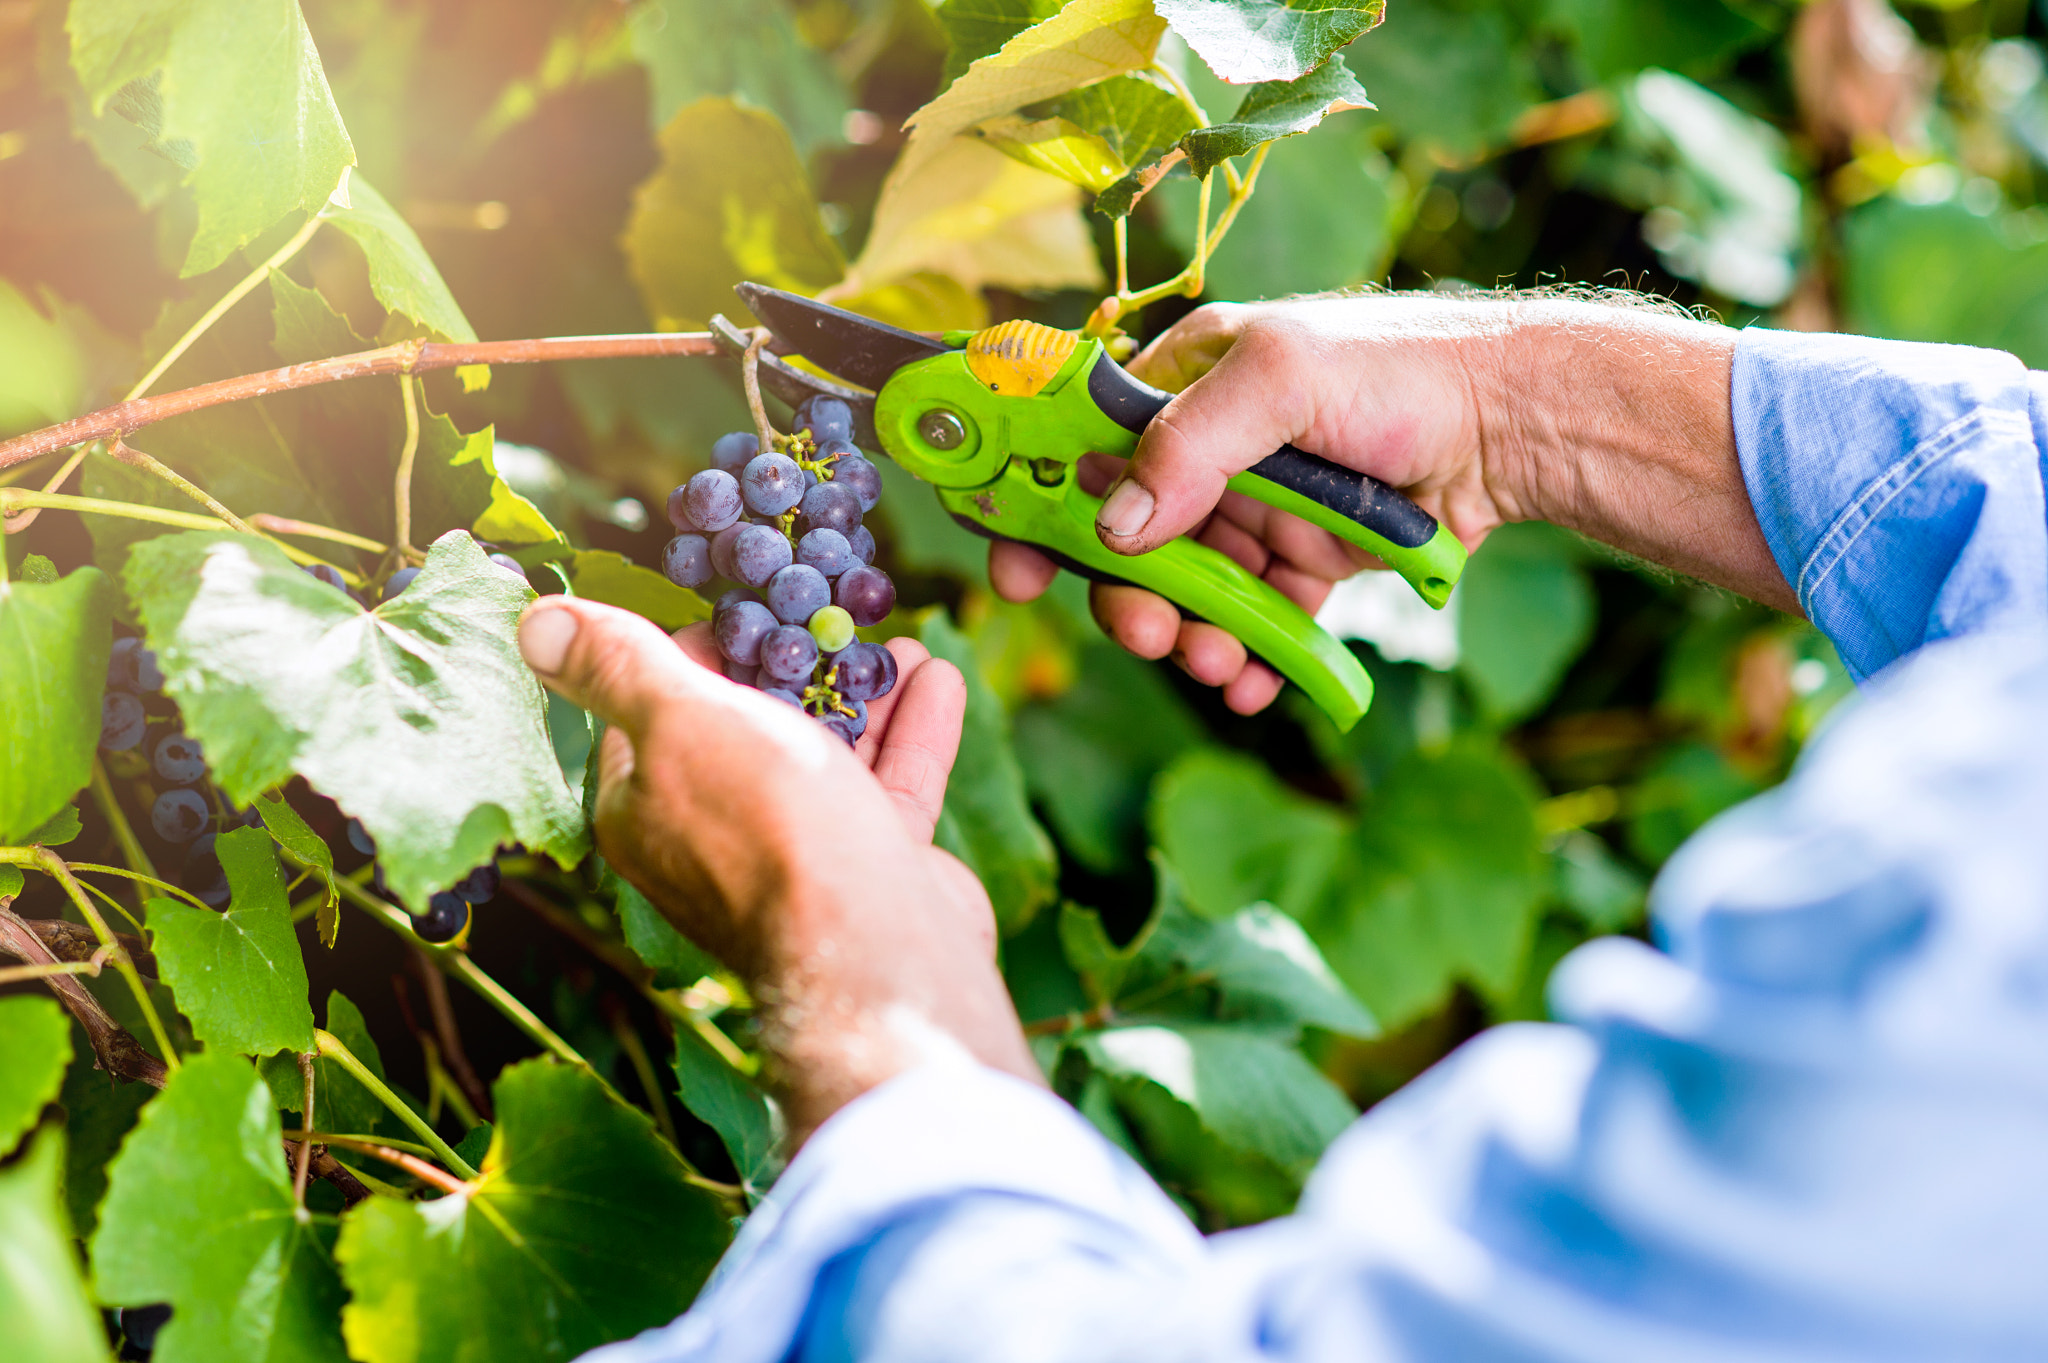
left=1475, top=299, right=1800, bottom=614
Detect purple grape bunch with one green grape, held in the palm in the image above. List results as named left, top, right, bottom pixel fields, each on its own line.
left=662, top=397, right=897, bottom=743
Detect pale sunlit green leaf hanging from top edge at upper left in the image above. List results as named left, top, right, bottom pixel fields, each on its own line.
left=66, top=0, right=356, bottom=276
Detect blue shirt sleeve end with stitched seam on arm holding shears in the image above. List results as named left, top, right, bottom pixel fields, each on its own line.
left=1731, top=327, right=2048, bottom=679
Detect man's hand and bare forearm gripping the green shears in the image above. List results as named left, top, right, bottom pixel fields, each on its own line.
left=989, top=295, right=1796, bottom=714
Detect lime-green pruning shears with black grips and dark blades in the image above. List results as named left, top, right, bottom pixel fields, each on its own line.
left=711, top=284, right=1464, bottom=729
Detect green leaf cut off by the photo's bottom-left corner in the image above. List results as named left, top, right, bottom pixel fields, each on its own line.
left=0, top=1128, right=114, bottom=1363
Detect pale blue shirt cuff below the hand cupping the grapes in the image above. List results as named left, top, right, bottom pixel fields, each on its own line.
left=586, top=1060, right=1202, bottom=1363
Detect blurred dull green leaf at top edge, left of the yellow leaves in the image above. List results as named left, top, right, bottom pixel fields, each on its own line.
left=631, top=0, right=850, bottom=153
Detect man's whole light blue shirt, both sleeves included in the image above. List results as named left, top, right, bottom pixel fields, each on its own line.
left=594, top=329, right=2048, bottom=1363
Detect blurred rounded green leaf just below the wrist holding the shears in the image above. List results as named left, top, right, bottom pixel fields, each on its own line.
left=1458, top=522, right=1593, bottom=724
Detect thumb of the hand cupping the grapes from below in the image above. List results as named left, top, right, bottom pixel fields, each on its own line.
left=518, top=596, right=711, bottom=739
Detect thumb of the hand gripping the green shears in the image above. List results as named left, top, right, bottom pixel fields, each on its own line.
left=1096, top=329, right=1313, bottom=555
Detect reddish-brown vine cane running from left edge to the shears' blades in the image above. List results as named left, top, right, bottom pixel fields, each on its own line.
left=0, top=332, right=719, bottom=472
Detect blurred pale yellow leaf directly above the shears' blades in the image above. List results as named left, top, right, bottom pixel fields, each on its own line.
left=834, top=137, right=1102, bottom=297
